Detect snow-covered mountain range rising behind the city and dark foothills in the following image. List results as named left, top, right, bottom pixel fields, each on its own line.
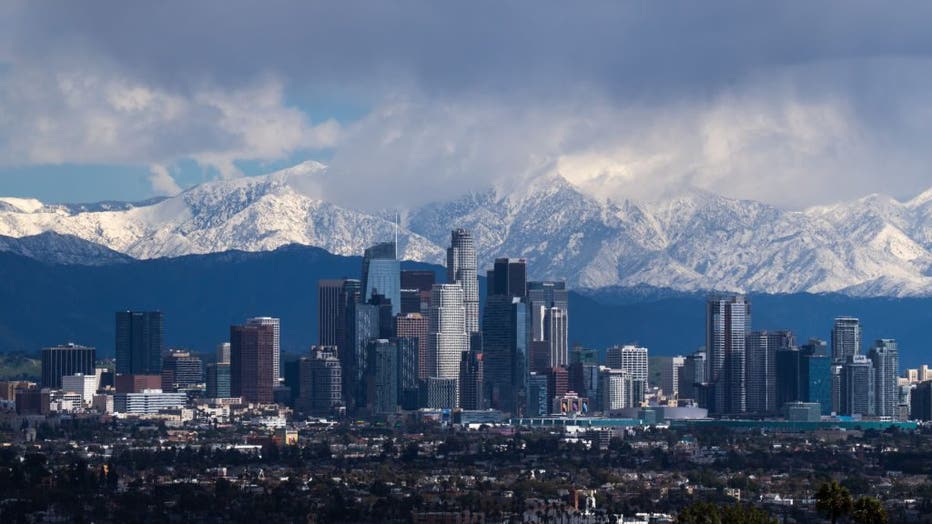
left=0, top=162, right=932, bottom=296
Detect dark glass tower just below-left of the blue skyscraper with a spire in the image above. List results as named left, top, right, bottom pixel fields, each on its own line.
left=339, top=302, right=379, bottom=409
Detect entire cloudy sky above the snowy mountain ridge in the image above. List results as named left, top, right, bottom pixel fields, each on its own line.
left=0, top=0, right=932, bottom=209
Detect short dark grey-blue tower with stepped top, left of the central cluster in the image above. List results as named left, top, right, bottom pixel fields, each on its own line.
left=296, top=346, right=343, bottom=415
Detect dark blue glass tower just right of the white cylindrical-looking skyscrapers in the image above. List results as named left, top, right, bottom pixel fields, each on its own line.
left=482, top=295, right=529, bottom=414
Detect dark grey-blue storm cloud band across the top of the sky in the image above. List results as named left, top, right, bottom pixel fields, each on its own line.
left=14, top=0, right=932, bottom=97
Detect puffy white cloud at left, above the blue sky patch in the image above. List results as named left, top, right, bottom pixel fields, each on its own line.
left=0, top=66, right=340, bottom=177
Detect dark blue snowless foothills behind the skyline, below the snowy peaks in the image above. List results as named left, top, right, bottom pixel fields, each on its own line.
left=0, top=243, right=932, bottom=367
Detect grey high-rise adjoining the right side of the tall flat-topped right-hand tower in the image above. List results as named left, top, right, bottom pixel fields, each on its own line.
left=745, top=331, right=796, bottom=414
